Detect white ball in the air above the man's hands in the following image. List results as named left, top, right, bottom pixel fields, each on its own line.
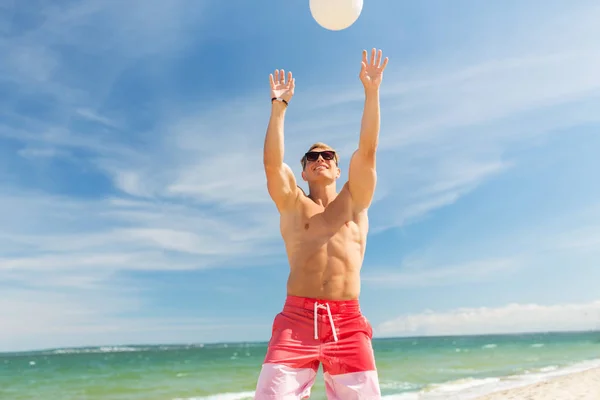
left=310, top=0, right=363, bottom=31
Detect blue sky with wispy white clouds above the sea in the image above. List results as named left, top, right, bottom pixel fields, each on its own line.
left=0, top=0, right=600, bottom=351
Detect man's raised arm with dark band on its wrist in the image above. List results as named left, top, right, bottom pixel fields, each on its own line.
left=263, top=70, right=298, bottom=212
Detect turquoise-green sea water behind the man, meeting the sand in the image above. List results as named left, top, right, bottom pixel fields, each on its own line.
left=0, top=332, right=600, bottom=400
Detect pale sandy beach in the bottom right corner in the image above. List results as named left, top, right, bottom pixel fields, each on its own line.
left=477, top=368, right=600, bottom=400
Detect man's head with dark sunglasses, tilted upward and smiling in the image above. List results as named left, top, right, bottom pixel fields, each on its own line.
left=300, top=142, right=340, bottom=184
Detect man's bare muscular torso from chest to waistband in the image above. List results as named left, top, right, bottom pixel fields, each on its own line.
left=281, top=194, right=367, bottom=300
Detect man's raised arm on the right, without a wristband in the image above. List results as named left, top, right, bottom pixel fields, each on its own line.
left=348, top=49, right=388, bottom=211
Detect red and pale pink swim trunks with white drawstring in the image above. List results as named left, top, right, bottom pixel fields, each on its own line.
left=254, top=296, right=381, bottom=400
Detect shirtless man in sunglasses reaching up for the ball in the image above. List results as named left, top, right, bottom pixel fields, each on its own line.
left=255, top=49, right=388, bottom=400
